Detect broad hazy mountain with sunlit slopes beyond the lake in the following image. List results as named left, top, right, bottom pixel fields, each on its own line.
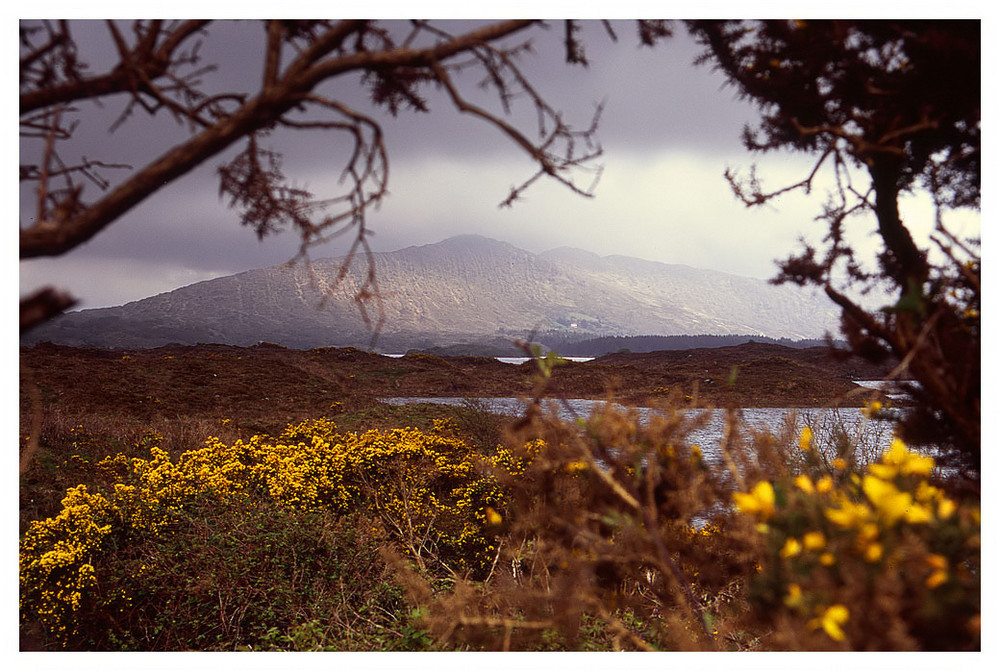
left=21, top=235, right=836, bottom=351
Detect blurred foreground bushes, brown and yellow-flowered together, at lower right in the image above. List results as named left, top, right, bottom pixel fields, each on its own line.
left=394, top=405, right=980, bottom=650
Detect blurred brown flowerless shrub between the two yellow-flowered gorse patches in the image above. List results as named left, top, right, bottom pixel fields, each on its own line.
left=410, top=405, right=754, bottom=650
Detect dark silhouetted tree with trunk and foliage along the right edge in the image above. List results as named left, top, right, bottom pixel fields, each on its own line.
left=688, top=20, right=981, bottom=466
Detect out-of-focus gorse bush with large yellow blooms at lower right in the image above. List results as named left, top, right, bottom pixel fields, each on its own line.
left=733, top=436, right=980, bottom=650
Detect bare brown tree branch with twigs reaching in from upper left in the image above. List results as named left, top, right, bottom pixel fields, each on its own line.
left=20, top=20, right=616, bottom=336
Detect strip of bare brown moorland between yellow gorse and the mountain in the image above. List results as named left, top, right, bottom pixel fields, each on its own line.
left=21, top=343, right=890, bottom=421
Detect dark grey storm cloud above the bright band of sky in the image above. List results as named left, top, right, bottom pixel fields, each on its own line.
left=22, top=20, right=744, bottom=252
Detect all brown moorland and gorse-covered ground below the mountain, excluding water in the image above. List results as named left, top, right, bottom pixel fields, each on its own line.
left=20, top=344, right=980, bottom=650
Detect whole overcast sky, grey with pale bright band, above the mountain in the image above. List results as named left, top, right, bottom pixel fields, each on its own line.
left=20, top=10, right=979, bottom=308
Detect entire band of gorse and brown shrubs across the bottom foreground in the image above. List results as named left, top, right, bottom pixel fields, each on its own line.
left=20, top=396, right=981, bottom=650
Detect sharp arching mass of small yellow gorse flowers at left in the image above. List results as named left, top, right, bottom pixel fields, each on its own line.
left=20, top=420, right=524, bottom=644
